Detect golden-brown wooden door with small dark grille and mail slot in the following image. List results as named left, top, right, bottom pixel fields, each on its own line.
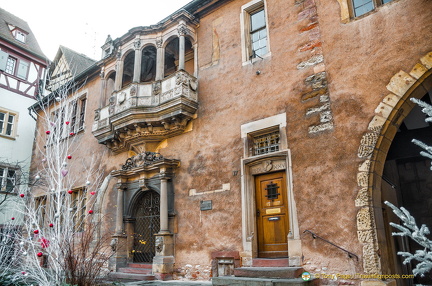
left=255, top=172, right=289, bottom=257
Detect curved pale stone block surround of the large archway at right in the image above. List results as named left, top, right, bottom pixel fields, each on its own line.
left=355, top=52, right=432, bottom=274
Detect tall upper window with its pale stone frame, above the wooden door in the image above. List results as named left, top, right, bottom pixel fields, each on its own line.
left=240, top=0, right=270, bottom=62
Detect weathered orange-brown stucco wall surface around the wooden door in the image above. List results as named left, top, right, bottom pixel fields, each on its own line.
left=28, top=0, right=432, bottom=279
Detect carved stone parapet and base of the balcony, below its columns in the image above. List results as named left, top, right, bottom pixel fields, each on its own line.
left=92, top=70, right=198, bottom=152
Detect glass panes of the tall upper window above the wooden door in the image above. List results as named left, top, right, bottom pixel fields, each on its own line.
left=249, top=7, right=268, bottom=58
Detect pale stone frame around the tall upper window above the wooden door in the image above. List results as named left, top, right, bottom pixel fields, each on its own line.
left=240, top=0, right=271, bottom=65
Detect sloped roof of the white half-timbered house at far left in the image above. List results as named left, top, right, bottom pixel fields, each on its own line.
left=0, top=8, right=46, bottom=60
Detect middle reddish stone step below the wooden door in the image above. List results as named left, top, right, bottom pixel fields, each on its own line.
left=234, top=267, right=304, bottom=279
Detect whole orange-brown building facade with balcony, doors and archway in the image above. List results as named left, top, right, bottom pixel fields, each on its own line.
left=29, top=0, right=432, bottom=284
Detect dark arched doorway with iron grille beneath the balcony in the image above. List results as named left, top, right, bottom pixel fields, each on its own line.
left=132, top=190, right=160, bottom=263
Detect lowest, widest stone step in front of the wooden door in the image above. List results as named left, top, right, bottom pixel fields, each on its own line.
left=212, top=276, right=319, bottom=286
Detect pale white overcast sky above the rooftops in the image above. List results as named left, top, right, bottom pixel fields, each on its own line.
left=0, top=0, right=191, bottom=60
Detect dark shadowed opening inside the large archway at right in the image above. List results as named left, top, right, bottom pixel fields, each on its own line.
left=381, top=90, right=432, bottom=285
